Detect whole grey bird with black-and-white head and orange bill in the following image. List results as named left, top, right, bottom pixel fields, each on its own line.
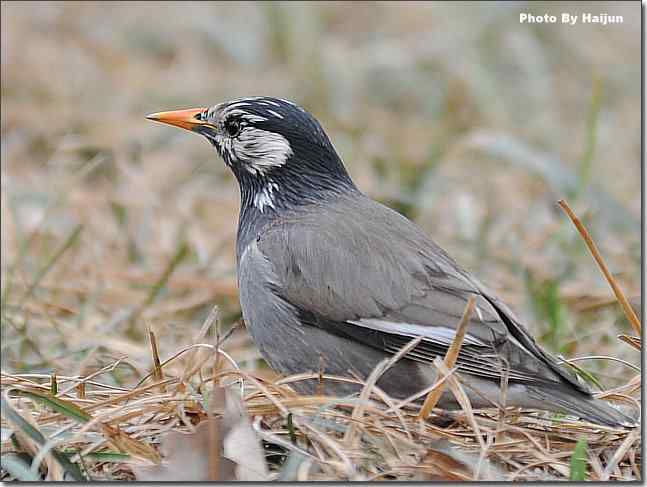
left=147, top=96, right=635, bottom=427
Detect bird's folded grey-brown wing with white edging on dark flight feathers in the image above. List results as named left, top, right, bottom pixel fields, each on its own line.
left=258, top=196, right=587, bottom=390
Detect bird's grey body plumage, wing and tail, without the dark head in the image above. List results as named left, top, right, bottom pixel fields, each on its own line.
left=238, top=194, right=629, bottom=424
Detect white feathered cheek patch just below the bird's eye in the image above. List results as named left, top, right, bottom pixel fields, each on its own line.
left=233, top=127, right=292, bottom=174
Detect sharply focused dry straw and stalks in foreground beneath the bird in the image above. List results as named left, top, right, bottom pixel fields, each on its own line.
left=1, top=213, right=642, bottom=481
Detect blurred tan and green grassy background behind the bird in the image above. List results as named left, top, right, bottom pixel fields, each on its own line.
left=1, top=2, right=641, bottom=387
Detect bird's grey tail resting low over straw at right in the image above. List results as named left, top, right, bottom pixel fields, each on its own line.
left=529, top=387, right=638, bottom=427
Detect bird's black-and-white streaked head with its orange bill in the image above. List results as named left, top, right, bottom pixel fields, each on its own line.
left=147, top=97, right=354, bottom=211
